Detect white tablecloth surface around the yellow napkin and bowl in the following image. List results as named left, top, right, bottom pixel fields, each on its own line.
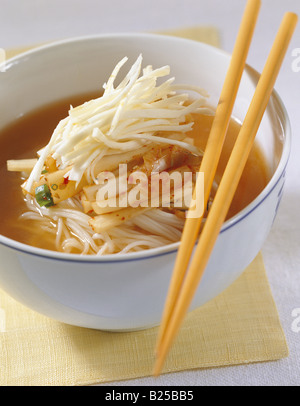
left=0, top=0, right=300, bottom=386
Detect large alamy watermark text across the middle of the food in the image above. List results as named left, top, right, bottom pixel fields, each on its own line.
left=94, top=164, right=205, bottom=218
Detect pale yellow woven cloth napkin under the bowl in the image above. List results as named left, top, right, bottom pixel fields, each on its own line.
left=0, top=27, right=288, bottom=386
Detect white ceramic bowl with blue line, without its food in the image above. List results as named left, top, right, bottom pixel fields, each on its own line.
left=0, top=34, right=291, bottom=331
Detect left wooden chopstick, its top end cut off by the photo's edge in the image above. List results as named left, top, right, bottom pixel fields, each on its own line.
left=156, top=0, right=261, bottom=354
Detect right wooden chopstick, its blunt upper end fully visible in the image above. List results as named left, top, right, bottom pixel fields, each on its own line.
left=154, top=13, right=298, bottom=376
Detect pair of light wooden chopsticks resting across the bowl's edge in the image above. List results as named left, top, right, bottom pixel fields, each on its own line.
left=153, top=0, right=298, bottom=376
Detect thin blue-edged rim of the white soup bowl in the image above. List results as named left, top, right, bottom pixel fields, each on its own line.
left=0, top=32, right=291, bottom=264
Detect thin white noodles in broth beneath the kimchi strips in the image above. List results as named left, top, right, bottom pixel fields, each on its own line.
left=21, top=195, right=188, bottom=255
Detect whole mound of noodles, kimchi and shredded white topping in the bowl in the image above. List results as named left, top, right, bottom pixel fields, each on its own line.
left=10, top=55, right=211, bottom=256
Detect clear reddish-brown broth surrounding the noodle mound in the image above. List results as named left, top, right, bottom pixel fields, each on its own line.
left=0, top=93, right=269, bottom=250
